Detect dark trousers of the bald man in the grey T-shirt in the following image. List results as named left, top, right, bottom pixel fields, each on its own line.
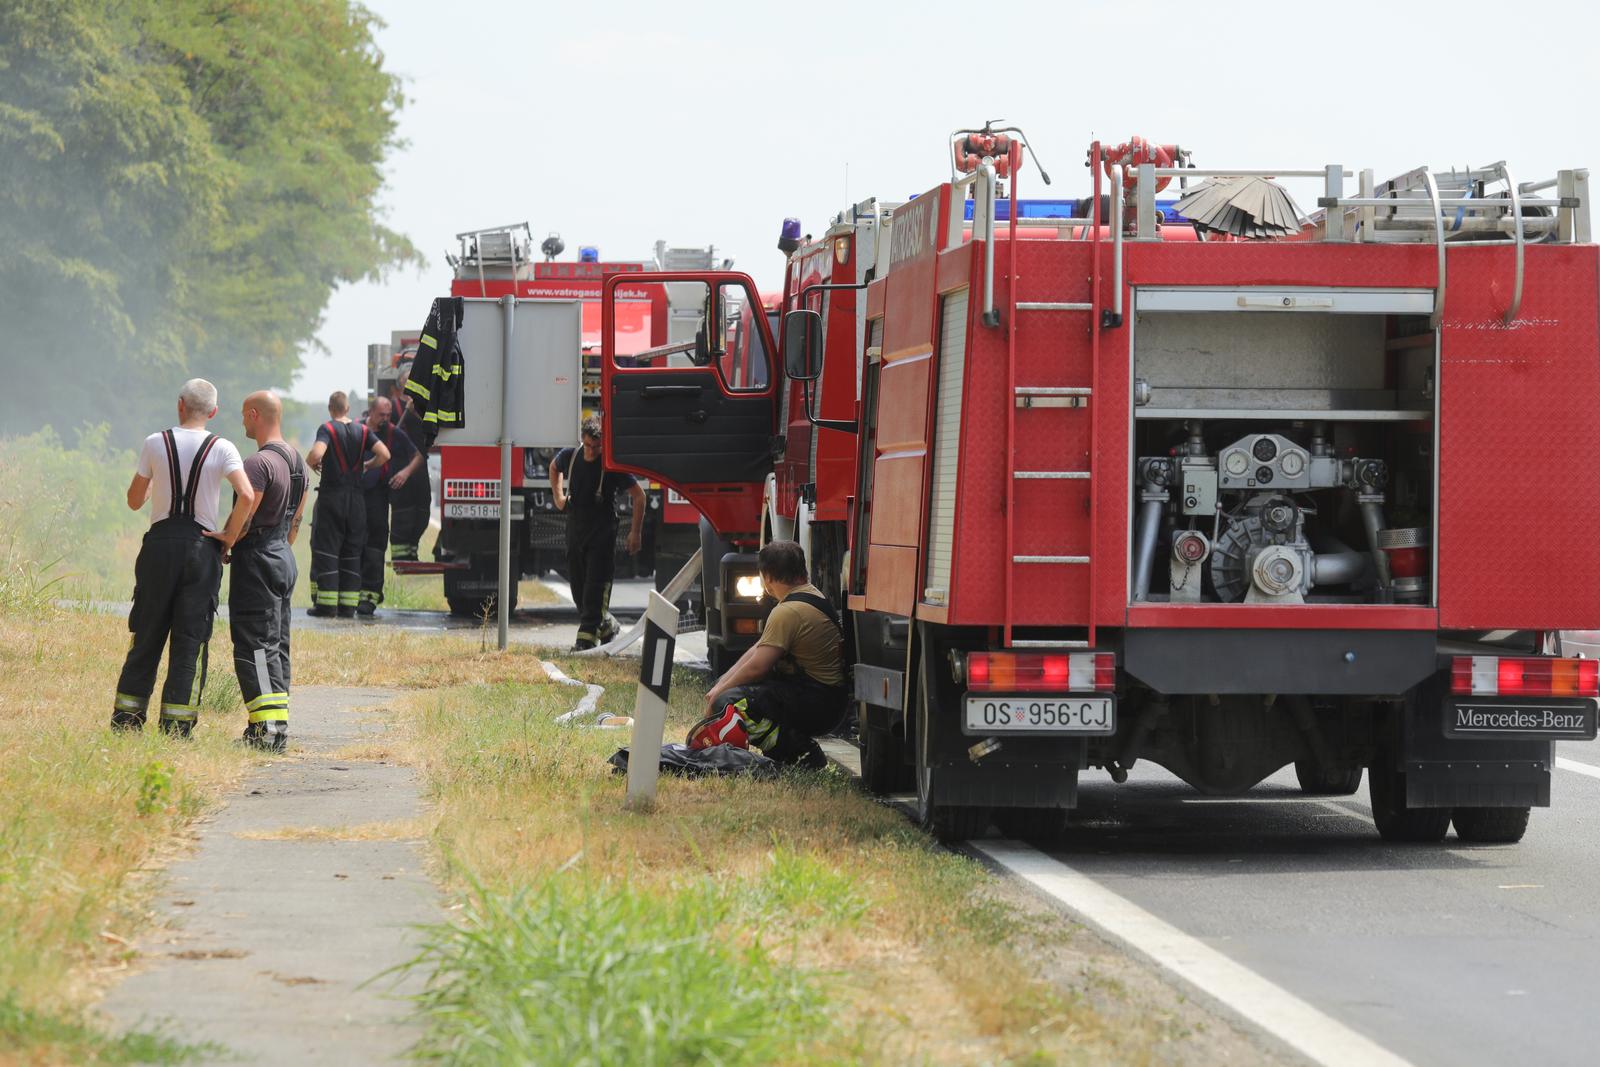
left=227, top=531, right=299, bottom=733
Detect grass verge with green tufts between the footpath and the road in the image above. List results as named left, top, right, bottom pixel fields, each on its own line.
left=384, top=659, right=1209, bottom=1064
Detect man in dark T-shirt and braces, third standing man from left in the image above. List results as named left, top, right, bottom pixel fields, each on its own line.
left=306, top=392, right=389, bottom=619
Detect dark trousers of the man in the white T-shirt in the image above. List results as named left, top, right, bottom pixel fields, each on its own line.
left=112, top=515, right=222, bottom=733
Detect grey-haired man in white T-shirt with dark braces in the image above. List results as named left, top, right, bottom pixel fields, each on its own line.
left=110, top=378, right=256, bottom=737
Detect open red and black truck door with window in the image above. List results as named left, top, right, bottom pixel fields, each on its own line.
left=602, top=270, right=782, bottom=537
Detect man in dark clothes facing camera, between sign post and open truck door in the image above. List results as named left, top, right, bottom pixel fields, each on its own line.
left=550, top=416, right=645, bottom=651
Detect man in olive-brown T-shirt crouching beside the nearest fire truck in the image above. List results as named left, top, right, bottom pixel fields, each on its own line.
left=688, top=541, right=850, bottom=769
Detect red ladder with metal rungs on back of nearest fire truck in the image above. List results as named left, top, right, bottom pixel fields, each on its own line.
left=989, top=141, right=1122, bottom=648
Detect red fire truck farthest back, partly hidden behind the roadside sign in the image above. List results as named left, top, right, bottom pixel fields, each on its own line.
left=409, top=222, right=731, bottom=614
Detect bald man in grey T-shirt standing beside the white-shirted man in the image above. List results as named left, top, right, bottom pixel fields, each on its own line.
left=227, top=390, right=307, bottom=752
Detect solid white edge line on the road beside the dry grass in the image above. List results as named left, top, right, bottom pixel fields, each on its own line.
left=968, top=841, right=1410, bottom=1067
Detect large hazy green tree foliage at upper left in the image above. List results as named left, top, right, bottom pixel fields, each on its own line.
left=0, top=0, right=416, bottom=434
